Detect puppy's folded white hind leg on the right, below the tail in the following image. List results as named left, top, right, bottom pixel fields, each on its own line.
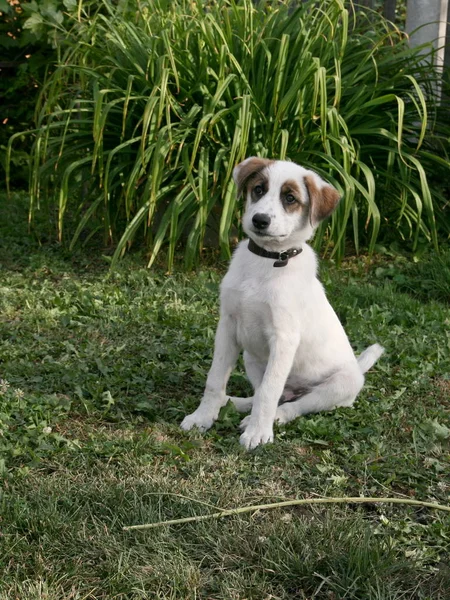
left=275, top=368, right=364, bottom=423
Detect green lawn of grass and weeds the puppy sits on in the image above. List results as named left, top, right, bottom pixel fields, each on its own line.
left=0, top=197, right=450, bottom=600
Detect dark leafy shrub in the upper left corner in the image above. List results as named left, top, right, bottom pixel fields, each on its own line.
left=0, top=0, right=111, bottom=189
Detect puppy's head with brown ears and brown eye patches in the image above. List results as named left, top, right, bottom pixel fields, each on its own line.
left=233, top=157, right=340, bottom=250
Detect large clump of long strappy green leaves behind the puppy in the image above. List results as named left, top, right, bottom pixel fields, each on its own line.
left=7, top=0, right=449, bottom=268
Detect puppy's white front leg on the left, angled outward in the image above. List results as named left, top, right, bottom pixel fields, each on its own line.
left=181, top=314, right=239, bottom=431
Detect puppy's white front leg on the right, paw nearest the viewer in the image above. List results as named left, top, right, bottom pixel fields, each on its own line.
left=240, top=334, right=298, bottom=450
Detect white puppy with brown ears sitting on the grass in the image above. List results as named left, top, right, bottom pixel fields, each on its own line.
left=181, top=157, right=383, bottom=449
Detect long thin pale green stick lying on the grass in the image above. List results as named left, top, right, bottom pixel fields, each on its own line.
left=123, top=496, right=450, bottom=531
